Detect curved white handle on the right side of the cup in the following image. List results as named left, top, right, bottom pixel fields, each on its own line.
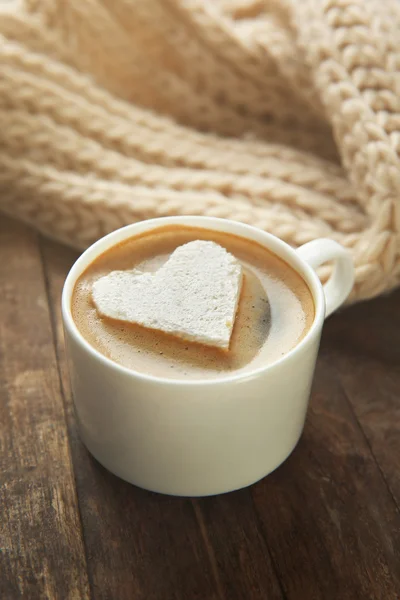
left=297, top=238, right=354, bottom=317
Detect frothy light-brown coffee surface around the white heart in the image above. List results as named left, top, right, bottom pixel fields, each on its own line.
left=71, top=225, right=314, bottom=379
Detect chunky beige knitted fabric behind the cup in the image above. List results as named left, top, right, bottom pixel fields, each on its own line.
left=0, top=0, right=400, bottom=300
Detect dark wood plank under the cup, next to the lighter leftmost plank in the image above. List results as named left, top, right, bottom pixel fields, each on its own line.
left=42, top=241, right=283, bottom=600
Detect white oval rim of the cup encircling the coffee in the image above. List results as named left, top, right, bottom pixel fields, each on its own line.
left=61, top=215, right=325, bottom=387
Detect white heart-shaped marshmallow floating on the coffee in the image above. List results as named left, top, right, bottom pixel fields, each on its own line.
left=92, top=240, right=242, bottom=349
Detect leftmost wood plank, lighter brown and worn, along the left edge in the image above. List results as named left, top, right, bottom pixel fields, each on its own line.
left=0, top=215, right=89, bottom=600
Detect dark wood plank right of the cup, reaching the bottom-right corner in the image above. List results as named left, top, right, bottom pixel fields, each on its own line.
left=252, top=352, right=400, bottom=600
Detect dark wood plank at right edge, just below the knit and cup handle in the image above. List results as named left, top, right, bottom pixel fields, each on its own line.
left=327, top=290, right=400, bottom=506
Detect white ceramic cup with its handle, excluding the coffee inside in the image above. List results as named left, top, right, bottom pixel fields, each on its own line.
left=62, top=217, right=353, bottom=496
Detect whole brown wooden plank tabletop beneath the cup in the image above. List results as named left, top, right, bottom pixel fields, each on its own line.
left=0, top=215, right=400, bottom=600
